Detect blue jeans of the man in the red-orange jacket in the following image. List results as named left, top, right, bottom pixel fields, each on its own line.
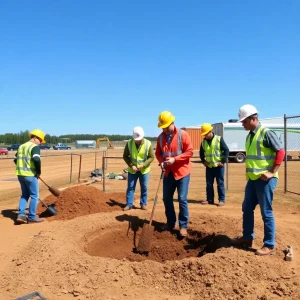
left=163, top=172, right=190, bottom=228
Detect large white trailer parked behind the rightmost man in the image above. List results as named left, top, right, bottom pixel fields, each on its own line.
left=212, top=117, right=300, bottom=163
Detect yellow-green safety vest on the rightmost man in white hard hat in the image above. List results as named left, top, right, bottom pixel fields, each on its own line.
left=246, top=126, right=278, bottom=180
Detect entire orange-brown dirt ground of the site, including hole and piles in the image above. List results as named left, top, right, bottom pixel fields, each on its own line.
left=0, top=141, right=300, bottom=300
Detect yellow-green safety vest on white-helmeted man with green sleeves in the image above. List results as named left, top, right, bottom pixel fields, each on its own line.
left=128, top=139, right=151, bottom=174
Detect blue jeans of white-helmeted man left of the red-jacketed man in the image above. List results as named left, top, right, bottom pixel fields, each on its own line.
left=126, top=172, right=150, bottom=207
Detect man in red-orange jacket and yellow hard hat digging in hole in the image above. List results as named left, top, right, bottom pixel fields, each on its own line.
left=155, top=111, right=193, bottom=237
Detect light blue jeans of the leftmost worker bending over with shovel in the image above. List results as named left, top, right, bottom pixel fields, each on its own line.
left=18, top=176, right=39, bottom=220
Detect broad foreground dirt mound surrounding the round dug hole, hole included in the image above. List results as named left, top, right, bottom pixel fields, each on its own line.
left=0, top=211, right=300, bottom=300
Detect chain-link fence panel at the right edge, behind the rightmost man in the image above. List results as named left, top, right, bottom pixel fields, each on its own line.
left=284, top=115, right=300, bottom=195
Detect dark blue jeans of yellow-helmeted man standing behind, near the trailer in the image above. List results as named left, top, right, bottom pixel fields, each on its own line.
left=206, top=167, right=225, bottom=203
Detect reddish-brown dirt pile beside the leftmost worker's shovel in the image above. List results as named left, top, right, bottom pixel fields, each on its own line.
left=37, top=185, right=126, bottom=220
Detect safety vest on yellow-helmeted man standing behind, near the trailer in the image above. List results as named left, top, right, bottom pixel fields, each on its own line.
left=202, top=135, right=223, bottom=168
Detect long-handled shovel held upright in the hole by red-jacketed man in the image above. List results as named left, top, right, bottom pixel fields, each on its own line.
left=136, top=171, right=164, bottom=253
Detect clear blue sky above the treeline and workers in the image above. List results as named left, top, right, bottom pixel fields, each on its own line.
left=0, top=0, right=300, bottom=136
